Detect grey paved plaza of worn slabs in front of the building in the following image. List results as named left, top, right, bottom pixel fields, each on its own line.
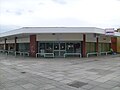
left=0, top=55, right=120, bottom=90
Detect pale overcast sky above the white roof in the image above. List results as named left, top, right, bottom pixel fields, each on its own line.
left=0, top=0, right=120, bottom=28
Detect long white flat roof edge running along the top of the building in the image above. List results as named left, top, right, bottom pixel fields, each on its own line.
left=0, top=27, right=120, bottom=38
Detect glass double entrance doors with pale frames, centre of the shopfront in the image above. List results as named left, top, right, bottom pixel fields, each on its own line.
left=54, top=42, right=66, bottom=57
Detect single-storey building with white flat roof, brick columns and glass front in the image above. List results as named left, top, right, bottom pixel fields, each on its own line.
left=0, top=27, right=120, bottom=57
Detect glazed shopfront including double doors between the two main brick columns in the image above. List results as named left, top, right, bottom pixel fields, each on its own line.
left=38, top=41, right=81, bottom=57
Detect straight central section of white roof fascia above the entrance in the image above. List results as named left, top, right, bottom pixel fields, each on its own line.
left=19, top=27, right=97, bottom=33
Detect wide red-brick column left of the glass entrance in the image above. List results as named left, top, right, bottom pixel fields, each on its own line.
left=30, top=35, right=37, bottom=57
